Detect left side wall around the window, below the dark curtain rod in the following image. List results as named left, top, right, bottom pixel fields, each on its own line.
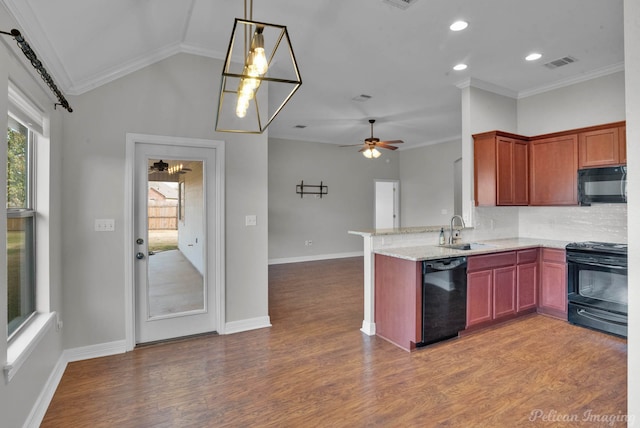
left=0, top=5, right=64, bottom=427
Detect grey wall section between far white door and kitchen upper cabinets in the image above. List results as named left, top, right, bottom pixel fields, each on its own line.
left=400, top=141, right=461, bottom=227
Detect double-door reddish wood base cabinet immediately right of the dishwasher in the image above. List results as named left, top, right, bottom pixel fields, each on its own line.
left=467, top=251, right=517, bottom=329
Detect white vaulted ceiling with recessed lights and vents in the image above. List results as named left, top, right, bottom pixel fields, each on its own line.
left=0, top=0, right=624, bottom=150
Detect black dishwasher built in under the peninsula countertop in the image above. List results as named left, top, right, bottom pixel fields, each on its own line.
left=417, top=257, right=467, bottom=346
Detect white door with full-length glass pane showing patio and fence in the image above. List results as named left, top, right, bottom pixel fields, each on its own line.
left=134, top=143, right=218, bottom=343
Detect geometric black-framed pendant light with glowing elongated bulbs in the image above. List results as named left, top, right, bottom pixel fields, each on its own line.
left=216, top=0, right=302, bottom=134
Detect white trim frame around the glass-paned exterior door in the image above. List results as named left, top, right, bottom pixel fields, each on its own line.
left=123, top=133, right=226, bottom=351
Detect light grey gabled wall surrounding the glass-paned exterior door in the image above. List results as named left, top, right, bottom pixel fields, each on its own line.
left=62, top=54, right=268, bottom=348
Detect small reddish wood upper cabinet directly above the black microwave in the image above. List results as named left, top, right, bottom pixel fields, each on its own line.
left=578, top=127, right=620, bottom=168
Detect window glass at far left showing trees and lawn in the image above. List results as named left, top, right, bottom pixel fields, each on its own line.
left=7, top=116, right=36, bottom=338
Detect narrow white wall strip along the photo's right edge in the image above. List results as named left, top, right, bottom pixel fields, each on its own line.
left=624, top=0, right=640, bottom=420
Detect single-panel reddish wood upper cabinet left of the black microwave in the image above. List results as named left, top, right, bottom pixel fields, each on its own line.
left=529, top=134, right=578, bottom=205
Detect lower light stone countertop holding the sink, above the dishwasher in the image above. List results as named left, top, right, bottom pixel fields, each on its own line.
left=374, top=237, right=569, bottom=262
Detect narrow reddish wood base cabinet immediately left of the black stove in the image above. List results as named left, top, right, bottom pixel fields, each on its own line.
left=538, top=248, right=567, bottom=320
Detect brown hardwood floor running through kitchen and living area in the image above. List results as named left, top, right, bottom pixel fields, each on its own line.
left=42, top=258, right=627, bottom=427
